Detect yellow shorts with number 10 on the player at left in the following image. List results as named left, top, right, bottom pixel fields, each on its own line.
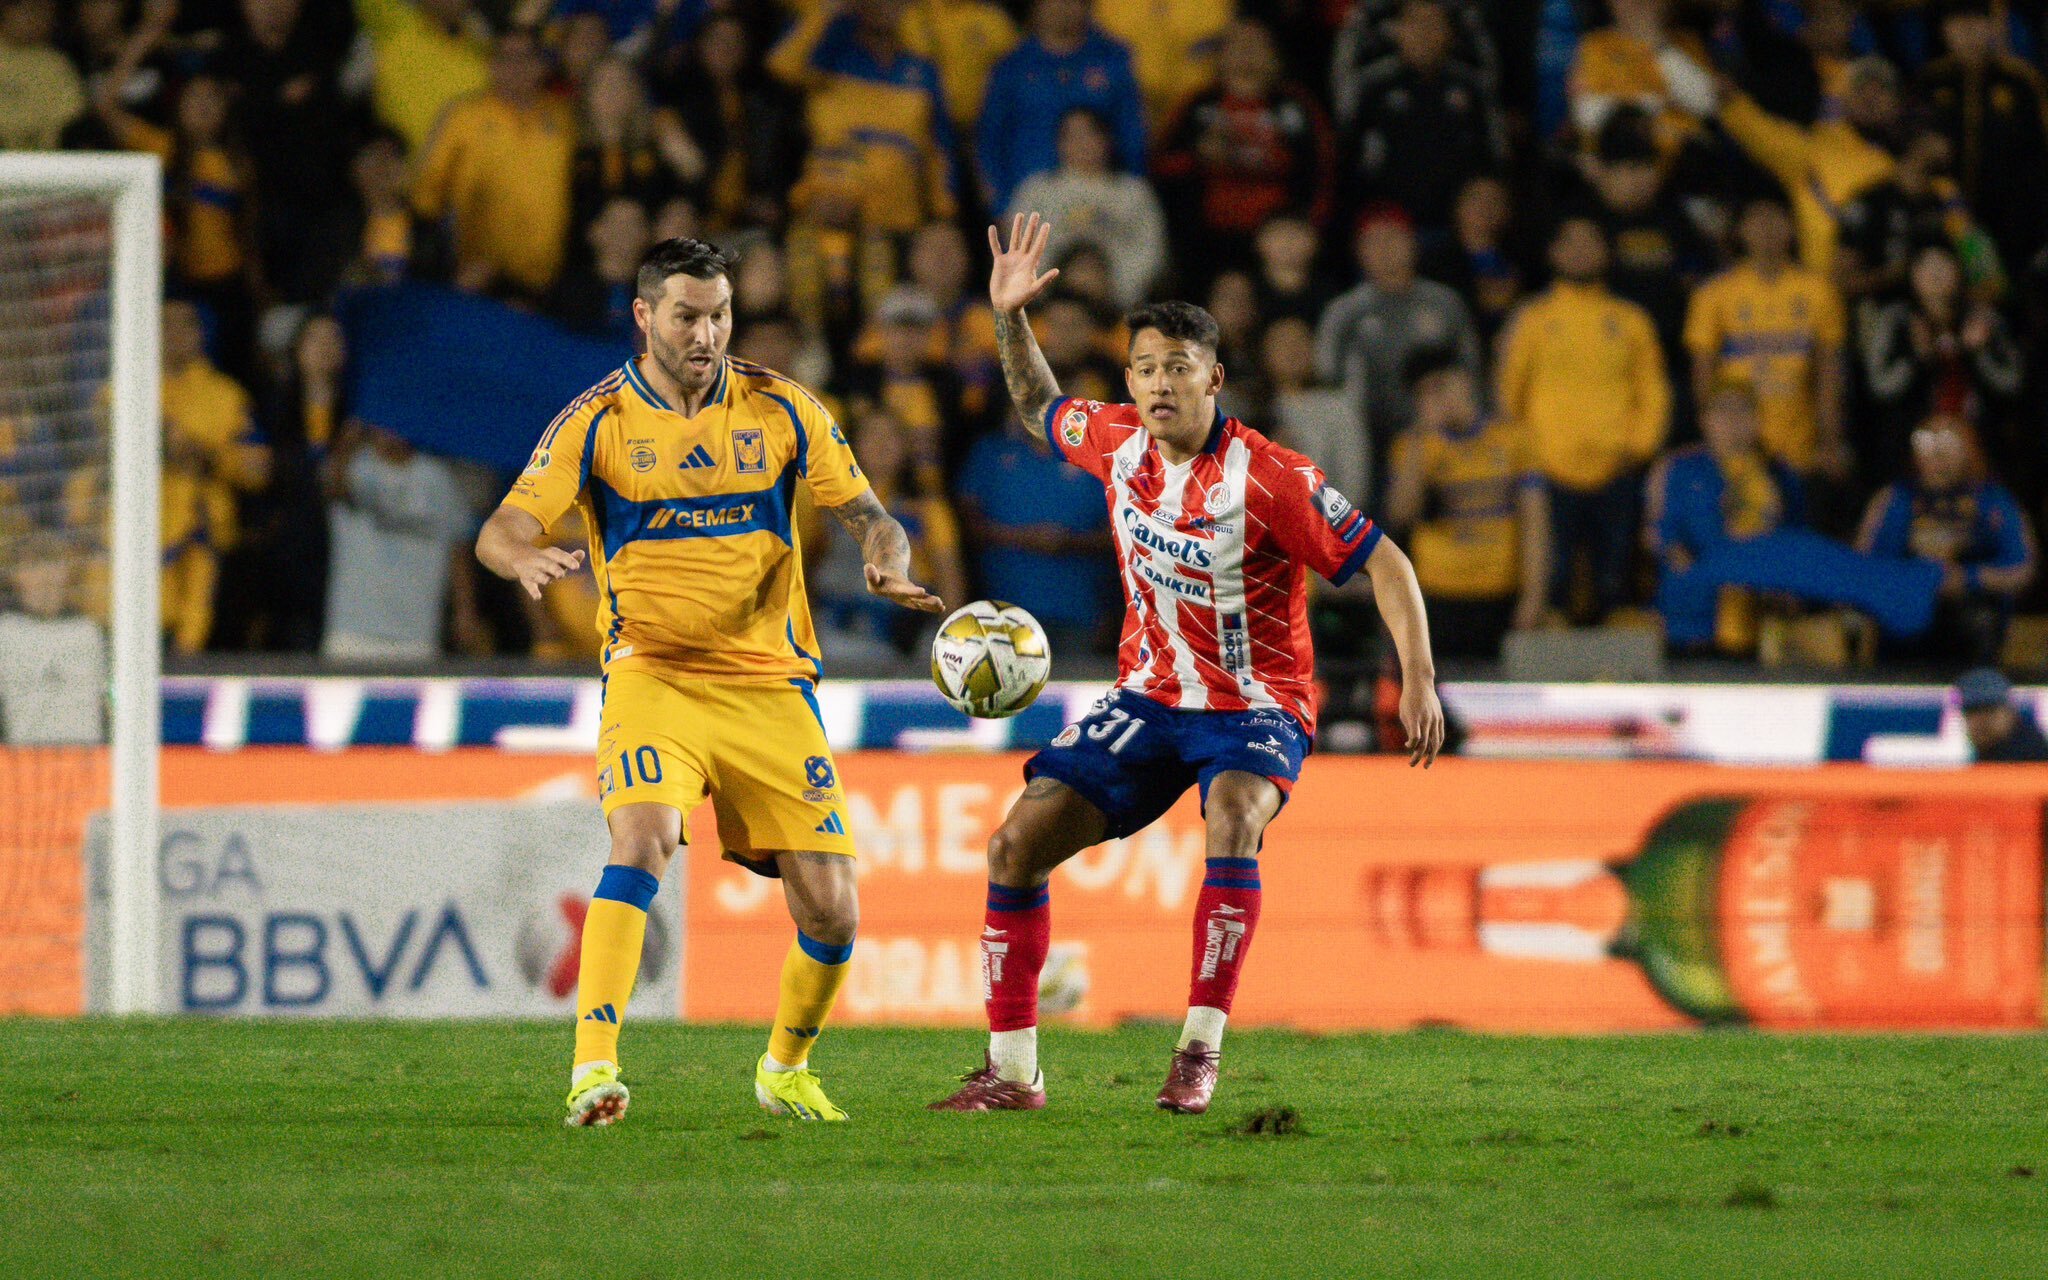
left=598, top=670, right=854, bottom=862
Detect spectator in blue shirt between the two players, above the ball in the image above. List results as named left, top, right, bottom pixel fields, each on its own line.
left=956, top=425, right=1116, bottom=653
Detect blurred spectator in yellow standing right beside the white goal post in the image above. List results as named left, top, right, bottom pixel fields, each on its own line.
left=162, top=301, right=270, bottom=655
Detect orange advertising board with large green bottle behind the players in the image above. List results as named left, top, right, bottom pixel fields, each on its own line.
left=0, top=748, right=2048, bottom=1032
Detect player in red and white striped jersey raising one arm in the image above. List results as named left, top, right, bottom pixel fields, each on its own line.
left=932, top=213, right=1444, bottom=1114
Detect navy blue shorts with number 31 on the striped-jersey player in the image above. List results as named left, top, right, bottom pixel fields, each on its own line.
left=1024, top=688, right=1313, bottom=840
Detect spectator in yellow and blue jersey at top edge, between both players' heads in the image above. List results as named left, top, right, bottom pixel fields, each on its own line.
left=768, top=0, right=954, bottom=233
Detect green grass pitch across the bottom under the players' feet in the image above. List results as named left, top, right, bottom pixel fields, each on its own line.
left=0, top=1020, right=2048, bottom=1280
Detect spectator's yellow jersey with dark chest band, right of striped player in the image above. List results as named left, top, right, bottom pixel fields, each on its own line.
left=1393, top=418, right=1542, bottom=600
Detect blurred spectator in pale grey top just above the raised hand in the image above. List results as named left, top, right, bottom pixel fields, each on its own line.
left=1010, top=106, right=1165, bottom=309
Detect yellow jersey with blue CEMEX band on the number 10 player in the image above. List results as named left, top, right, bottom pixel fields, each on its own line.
left=506, top=356, right=868, bottom=682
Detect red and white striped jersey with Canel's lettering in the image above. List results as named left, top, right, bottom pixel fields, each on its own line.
left=1044, top=397, right=1380, bottom=733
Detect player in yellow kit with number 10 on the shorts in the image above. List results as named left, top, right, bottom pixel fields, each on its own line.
left=477, top=240, right=944, bottom=1124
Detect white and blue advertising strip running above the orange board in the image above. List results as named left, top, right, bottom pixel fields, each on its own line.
left=164, top=676, right=2048, bottom=764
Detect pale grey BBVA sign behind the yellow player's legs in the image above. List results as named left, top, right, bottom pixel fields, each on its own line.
left=88, top=801, right=682, bottom=1018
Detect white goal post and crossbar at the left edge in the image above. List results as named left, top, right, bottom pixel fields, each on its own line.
left=0, top=152, right=164, bottom=1014
